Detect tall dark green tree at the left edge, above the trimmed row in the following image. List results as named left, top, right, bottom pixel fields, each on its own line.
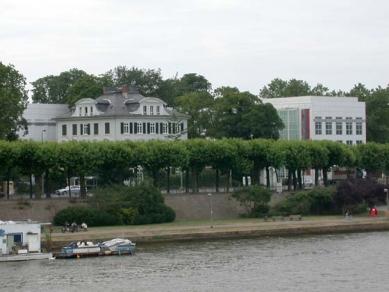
left=0, top=62, right=28, bottom=141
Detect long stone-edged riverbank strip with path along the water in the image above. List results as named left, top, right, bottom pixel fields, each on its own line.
left=42, top=217, right=389, bottom=250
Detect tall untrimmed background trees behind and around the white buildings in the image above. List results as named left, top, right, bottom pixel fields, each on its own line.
left=0, top=62, right=389, bottom=143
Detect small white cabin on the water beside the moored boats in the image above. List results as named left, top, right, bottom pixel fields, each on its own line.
left=0, top=221, right=41, bottom=256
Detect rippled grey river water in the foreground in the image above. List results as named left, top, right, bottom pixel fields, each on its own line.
left=0, top=232, right=389, bottom=292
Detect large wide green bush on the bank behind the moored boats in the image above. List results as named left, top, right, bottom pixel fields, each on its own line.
left=53, top=182, right=176, bottom=226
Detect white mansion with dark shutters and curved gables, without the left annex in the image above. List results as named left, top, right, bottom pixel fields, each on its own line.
left=56, top=87, right=189, bottom=142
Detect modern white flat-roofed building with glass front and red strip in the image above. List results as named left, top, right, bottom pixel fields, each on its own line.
left=263, top=96, right=366, bottom=145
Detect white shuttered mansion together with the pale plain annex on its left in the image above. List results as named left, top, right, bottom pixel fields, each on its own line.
left=19, top=86, right=190, bottom=142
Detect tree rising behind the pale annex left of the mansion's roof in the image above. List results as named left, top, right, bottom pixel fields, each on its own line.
left=31, top=69, right=87, bottom=104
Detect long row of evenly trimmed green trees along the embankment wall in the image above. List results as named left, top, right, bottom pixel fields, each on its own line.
left=0, top=139, right=389, bottom=198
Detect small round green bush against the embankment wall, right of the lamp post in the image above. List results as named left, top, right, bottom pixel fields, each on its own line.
left=231, top=186, right=272, bottom=218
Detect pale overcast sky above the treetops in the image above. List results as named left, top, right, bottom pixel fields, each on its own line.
left=0, top=0, right=389, bottom=94
